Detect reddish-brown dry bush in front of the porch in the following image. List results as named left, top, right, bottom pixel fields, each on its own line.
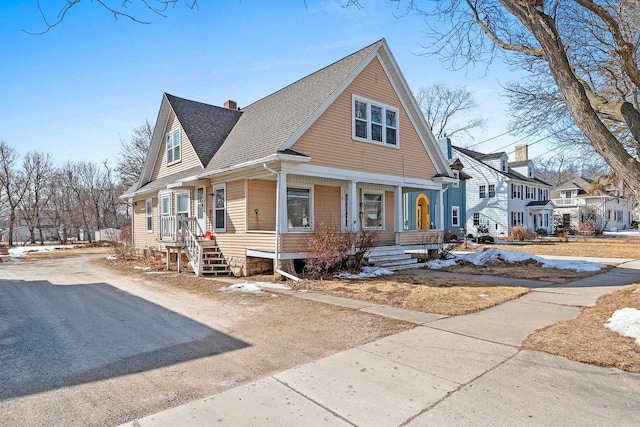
left=305, top=224, right=376, bottom=277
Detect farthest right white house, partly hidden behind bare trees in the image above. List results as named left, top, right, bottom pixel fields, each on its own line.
left=551, top=178, right=635, bottom=231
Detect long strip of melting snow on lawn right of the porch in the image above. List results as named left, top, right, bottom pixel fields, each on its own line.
left=427, top=248, right=606, bottom=271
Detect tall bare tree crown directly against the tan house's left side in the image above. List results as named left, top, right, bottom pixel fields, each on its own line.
left=116, top=120, right=153, bottom=190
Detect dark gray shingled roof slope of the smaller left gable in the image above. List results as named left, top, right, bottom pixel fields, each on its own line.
left=165, top=93, right=242, bottom=166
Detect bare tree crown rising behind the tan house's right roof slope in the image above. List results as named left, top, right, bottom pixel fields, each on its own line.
left=414, top=83, right=487, bottom=138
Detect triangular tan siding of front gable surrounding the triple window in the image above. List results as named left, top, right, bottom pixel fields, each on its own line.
left=292, top=58, right=436, bottom=179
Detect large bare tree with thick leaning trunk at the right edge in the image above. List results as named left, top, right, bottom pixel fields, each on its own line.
left=346, top=0, right=640, bottom=198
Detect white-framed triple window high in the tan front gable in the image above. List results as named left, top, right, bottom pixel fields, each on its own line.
left=353, top=96, right=399, bottom=147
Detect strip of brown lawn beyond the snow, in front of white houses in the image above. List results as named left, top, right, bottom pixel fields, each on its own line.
left=458, top=237, right=640, bottom=259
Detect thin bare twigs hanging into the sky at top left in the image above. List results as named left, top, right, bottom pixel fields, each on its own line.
left=26, top=0, right=198, bottom=35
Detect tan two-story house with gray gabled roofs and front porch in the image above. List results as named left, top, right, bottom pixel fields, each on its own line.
left=122, top=39, right=457, bottom=275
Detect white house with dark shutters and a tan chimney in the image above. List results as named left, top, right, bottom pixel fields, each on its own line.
left=453, top=145, right=554, bottom=237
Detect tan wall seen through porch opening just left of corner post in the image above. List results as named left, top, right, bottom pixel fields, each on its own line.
left=247, top=179, right=276, bottom=231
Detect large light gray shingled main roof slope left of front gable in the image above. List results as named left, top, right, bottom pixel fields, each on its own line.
left=207, top=41, right=381, bottom=170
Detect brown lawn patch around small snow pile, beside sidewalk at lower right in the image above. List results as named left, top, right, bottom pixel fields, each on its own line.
left=521, top=283, right=640, bottom=373
